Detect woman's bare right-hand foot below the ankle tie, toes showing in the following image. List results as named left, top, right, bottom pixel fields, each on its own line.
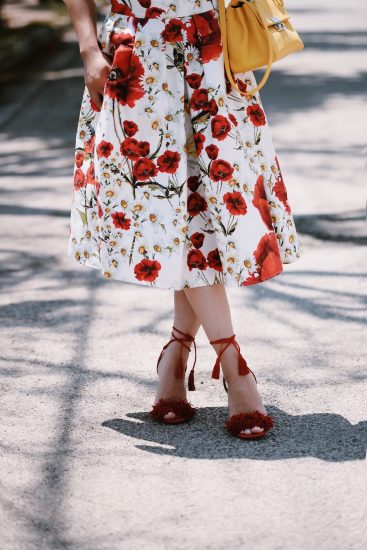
left=221, top=346, right=267, bottom=435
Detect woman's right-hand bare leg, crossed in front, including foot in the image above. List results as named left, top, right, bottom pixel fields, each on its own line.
left=184, top=284, right=266, bottom=432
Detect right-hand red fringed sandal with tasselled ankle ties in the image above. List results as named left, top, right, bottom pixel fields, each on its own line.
left=210, top=334, right=274, bottom=439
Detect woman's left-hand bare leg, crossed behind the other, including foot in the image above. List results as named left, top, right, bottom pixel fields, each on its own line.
left=155, top=290, right=200, bottom=419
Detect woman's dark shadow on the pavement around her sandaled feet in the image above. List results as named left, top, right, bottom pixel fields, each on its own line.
left=102, top=406, right=367, bottom=462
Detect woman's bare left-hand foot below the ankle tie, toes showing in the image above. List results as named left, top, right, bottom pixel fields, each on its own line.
left=154, top=330, right=190, bottom=420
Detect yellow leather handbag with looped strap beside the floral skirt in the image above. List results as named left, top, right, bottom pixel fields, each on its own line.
left=218, top=0, right=304, bottom=97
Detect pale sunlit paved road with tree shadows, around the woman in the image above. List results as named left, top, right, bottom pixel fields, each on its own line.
left=0, top=0, right=367, bottom=550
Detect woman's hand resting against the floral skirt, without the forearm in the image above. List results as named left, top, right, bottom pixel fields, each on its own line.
left=82, top=50, right=112, bottom=108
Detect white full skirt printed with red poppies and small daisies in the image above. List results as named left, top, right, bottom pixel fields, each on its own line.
left=67, top=0, right=300, bottom=290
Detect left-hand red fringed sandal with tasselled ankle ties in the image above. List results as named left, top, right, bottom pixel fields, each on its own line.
left=149, top=327, right=196, bottom=424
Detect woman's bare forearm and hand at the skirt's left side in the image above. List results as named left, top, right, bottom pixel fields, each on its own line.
left=64, top=0, right=111, bottom=107
